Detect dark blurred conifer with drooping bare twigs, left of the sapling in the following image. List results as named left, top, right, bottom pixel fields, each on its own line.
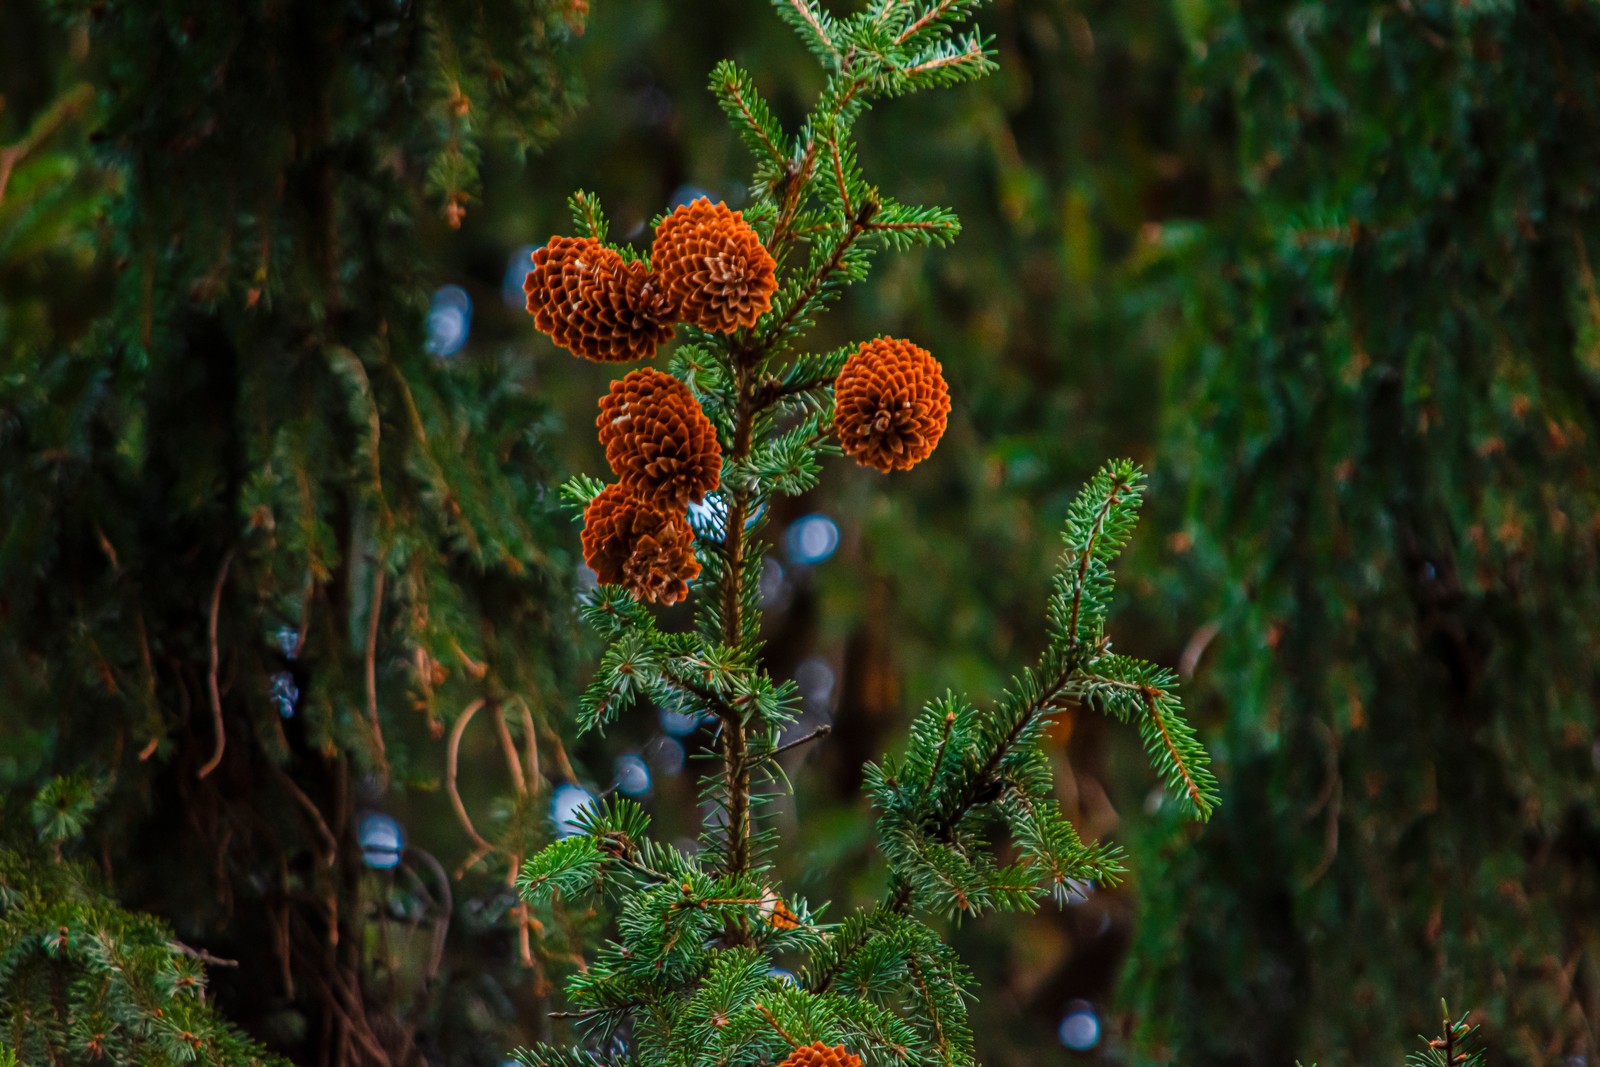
left=0, top=0, right=586, bottom=1064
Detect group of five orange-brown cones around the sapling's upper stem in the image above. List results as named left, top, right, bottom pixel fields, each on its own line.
left=523, top=198, right=950, bottom=605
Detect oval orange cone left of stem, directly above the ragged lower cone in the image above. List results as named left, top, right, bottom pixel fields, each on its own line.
left=595, top=366, right=722, bottom=510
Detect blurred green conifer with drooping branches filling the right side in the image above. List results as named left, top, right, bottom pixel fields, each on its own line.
left=1130, top=3, right=1600, bottom=1064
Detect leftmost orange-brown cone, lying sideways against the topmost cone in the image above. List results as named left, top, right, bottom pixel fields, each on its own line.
left=522, top=237, right=672, bottom=363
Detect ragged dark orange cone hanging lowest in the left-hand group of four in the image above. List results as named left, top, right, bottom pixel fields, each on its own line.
left=584, top=485, right=699, bottom=605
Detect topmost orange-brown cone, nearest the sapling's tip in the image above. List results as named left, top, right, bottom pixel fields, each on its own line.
left=650, top=197, right=778, bottom=333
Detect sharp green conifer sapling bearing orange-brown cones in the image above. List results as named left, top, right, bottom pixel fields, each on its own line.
left=518, top=0, right=1216, bottom=1067
